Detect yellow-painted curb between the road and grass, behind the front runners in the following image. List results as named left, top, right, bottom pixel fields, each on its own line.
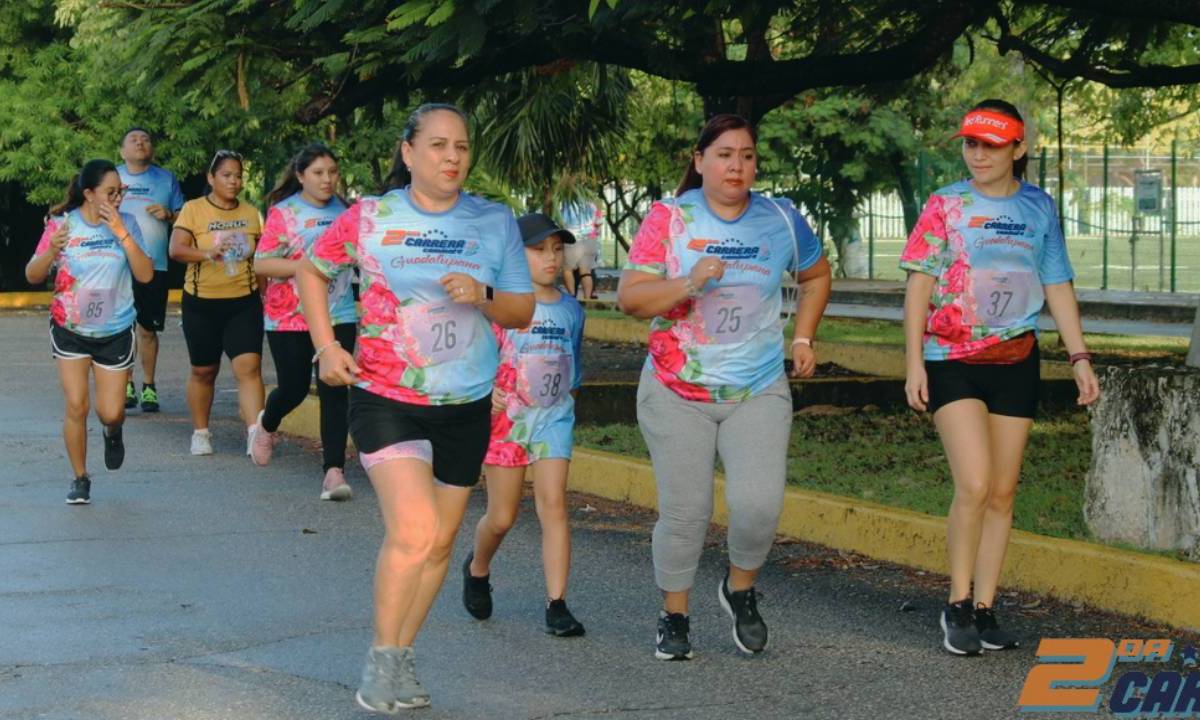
left=281, top=395, right=1200, bottom=629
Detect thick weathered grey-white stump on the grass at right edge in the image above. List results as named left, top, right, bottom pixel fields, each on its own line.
left=1084, top=365, right=1200, bottom=560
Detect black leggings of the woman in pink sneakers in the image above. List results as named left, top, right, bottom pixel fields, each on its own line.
left=263, top=323, right=358, bottom=470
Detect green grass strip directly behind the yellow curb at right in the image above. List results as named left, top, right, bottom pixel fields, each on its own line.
left=575, top=410, right=1092, bottom=540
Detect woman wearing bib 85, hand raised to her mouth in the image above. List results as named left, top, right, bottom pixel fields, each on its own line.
left=25, top=160, right=154, bottom=505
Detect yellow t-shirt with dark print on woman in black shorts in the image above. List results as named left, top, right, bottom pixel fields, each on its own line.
left=175, top=196, right=263, bottom=299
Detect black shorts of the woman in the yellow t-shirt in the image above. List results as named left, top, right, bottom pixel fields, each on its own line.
left=182, top=292, right=263, bottom=367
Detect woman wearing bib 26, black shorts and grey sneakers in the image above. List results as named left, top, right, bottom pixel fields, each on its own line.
left=298, top=104, right=534, bottom=712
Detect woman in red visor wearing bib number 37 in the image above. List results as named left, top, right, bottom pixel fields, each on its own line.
left=900, top=100, right=1099, bottom=655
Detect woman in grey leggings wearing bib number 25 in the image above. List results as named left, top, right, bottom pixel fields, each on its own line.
left=617, top=115, right=829, bottom=660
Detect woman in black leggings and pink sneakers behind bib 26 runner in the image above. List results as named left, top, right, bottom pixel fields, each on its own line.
left=251, top=144, right=358, bottom=500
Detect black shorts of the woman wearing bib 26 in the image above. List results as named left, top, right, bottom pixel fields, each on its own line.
left=350, top=386, right=492, bottom=487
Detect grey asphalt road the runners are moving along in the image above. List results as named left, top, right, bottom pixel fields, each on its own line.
left=0, top=313, right=1190, bottom=720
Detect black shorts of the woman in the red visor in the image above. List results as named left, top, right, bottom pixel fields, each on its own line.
left=925, top=344, right=1042, bottom=418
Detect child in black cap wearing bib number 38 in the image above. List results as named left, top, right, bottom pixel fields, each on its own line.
left=462, top=212, right=583, bottom=637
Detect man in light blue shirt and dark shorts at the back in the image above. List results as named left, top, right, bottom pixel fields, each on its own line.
left=116, top=127, right=184, bottom=413
